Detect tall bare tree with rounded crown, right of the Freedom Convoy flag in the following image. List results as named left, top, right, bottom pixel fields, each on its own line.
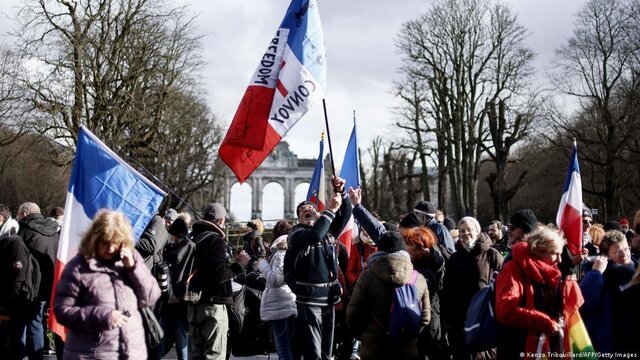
left=398, top=0, right=533, bottom=217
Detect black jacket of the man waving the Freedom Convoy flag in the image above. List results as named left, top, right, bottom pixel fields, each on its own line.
left=284, top=195, right=352, bottom=306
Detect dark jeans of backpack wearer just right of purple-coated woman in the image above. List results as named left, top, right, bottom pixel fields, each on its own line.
left=156, top=304, right=189, bottom=360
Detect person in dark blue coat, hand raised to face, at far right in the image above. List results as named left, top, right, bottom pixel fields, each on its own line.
left=580, top=230, right=635, bottom=353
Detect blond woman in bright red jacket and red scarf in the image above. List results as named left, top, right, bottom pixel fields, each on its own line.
left=496, top=226, right=582, bottom=359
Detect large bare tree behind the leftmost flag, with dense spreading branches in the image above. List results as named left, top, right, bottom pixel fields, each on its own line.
left=10, top=0, right=228, bottom=203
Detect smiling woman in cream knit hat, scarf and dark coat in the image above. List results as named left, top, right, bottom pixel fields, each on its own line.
left=440, top=216, right=503, bottom=360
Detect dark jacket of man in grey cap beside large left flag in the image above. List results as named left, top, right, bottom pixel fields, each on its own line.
left=18, top=214, right=59, bottom=301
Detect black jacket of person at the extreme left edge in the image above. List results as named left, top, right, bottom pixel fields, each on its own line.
left=0, top=235, right=29, bottom=316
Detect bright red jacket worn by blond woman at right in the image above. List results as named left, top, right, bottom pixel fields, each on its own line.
left=496, top=243, right=583, bottom=353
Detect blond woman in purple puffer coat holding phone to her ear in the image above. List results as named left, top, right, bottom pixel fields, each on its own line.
left=53, top=210, right=160, bottom=359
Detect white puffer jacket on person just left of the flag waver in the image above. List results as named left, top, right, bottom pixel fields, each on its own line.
left=258, top=235, right=298, bottom=320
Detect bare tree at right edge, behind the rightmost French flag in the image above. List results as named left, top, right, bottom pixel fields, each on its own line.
left=552, top=0, right=640, bottom=218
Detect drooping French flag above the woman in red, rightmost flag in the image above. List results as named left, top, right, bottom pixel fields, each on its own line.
left=556, top=141, right=582, bottom=255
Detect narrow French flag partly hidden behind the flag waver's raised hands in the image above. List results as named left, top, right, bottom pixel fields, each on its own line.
left=338, top=116, right=360, bottom=256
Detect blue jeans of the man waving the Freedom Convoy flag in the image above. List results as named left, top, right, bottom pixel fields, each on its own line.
left=291, top=304, right=335, bottom=360
